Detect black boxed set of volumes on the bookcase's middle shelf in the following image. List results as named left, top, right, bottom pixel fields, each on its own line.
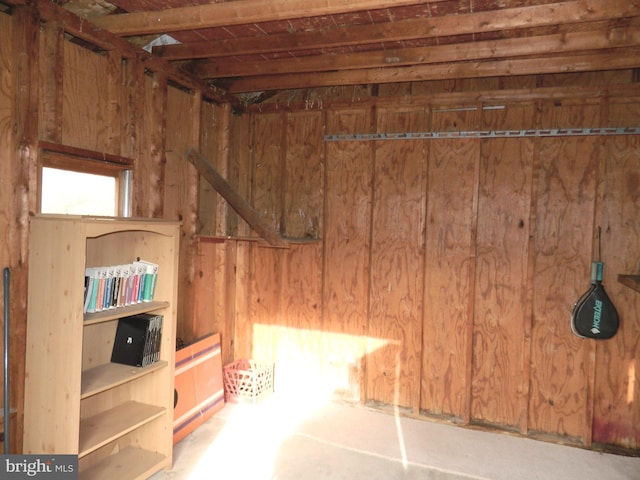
left=111, top=313, right=163, bottom=367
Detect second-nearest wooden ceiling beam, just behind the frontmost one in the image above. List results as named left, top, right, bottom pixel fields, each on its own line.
left=153, top=0, right=640, bottom=60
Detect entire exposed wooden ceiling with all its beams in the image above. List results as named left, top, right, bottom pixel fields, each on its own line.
left=48, top=0, right=640, bottom=100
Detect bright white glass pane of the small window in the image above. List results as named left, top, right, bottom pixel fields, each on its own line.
left=40, top=167, right=118, bottom=216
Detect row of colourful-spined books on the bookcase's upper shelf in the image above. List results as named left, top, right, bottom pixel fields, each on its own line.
left=83, top=260, right=158, bottom=313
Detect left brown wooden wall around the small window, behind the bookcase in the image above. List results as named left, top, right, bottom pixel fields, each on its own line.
left=0, top=2, right=216, bottom=453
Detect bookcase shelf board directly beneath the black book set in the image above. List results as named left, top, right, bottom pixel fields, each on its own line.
left=80, top=360, right=168, bottom=399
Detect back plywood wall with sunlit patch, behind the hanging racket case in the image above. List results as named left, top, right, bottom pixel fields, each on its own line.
left=199, top=92, right=640, bottom=450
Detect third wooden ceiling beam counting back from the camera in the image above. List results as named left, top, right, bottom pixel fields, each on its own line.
left=193, top=19, right=640, bottom=79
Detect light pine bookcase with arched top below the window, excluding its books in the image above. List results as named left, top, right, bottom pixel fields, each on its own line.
left=22, top=215, right=180, bottom=480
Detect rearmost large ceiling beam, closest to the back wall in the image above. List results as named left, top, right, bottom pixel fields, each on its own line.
left=229, top=47, right=640, bottom=93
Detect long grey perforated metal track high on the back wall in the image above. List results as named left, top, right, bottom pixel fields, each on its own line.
left=324, top=127, right=640, bottom=142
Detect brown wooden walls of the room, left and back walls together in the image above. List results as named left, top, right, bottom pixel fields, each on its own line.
left=0, top=2, right=640, bottom=452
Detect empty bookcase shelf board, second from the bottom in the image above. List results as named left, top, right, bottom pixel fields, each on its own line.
left=78, top=401, right=166, bottom=457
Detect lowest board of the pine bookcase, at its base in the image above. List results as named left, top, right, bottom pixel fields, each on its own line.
left=79, top=447, right=170, bottom=480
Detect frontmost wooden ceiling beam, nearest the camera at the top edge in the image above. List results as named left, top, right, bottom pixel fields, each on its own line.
left=89, top=0, right=445, bottom=36
